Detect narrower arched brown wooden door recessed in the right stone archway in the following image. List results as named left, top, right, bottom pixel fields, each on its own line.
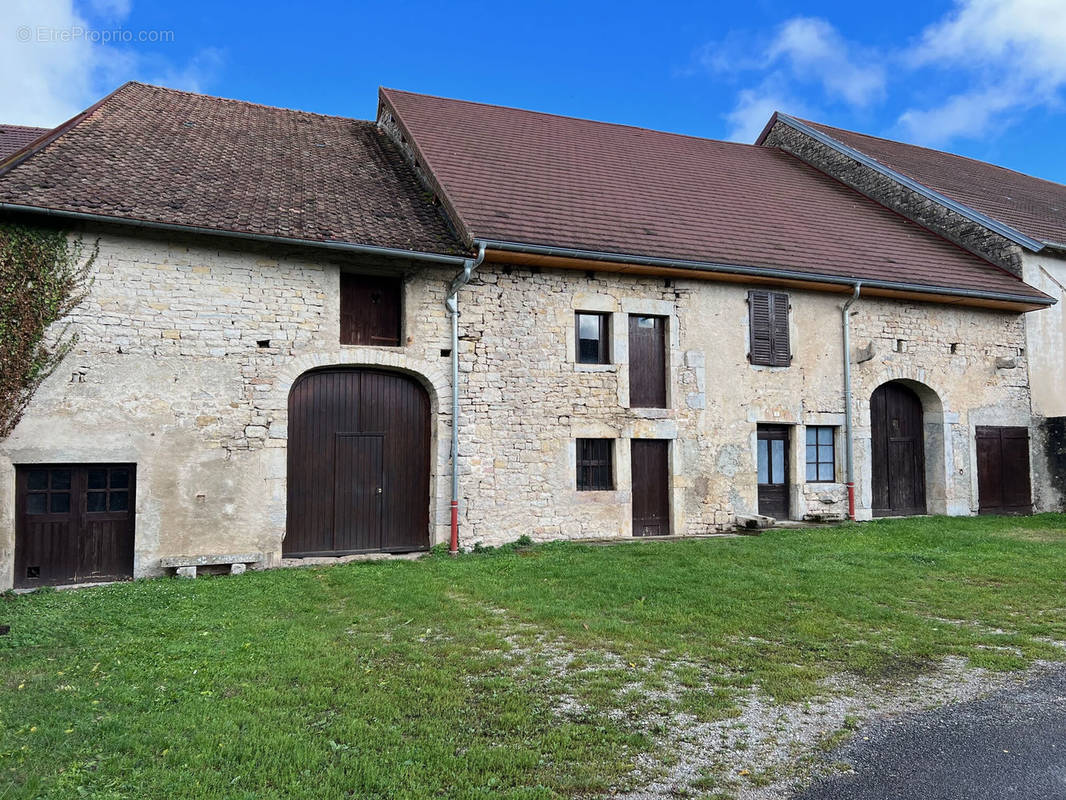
left=870, top=382, right=925, bottom=516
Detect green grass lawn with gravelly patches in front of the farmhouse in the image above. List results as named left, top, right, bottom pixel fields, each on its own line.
left=6, top=515, right=1066, bottom=800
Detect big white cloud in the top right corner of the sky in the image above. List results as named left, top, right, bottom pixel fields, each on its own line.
left=899, top=0, right=1066, bottom=144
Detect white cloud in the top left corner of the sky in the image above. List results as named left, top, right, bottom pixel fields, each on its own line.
left=0, top=0, right=223, bottom=127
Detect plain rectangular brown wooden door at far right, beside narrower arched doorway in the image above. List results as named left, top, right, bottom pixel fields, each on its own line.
left=976, top=426, right=1033, bottom=514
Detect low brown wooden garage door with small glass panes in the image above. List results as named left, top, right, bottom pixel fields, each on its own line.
left=15, top=464, right=136, bottom=588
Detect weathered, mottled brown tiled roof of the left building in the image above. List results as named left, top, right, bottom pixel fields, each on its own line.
left=0, top=83, right=459, bottom=254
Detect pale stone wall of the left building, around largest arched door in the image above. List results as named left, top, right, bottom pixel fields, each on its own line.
left=0, top=231, right=455, bottom=587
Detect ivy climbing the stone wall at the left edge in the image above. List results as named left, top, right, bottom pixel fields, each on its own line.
left=0, top=224, right=99, bottom=438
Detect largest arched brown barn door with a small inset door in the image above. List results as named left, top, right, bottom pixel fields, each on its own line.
left=281, top=368, right=430, bottom=557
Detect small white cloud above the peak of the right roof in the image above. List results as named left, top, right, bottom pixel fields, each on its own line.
left=768, top=17, right=885, bottom=106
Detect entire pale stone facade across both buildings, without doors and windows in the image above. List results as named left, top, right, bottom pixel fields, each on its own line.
left=0, top=231, right=1030, bottom=586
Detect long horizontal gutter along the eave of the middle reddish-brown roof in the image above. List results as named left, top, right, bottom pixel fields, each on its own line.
left=479, top=239, right=1057, bottom=306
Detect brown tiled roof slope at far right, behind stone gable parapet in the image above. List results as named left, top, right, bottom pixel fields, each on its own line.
left=801, top=121, right=1066, bottom=244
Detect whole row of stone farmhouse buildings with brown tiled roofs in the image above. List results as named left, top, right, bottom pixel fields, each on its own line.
left=0, top=83, right=1066, bottom=588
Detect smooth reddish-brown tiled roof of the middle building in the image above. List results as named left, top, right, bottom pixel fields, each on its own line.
left=382, top=90, right=1044, bottom=298
